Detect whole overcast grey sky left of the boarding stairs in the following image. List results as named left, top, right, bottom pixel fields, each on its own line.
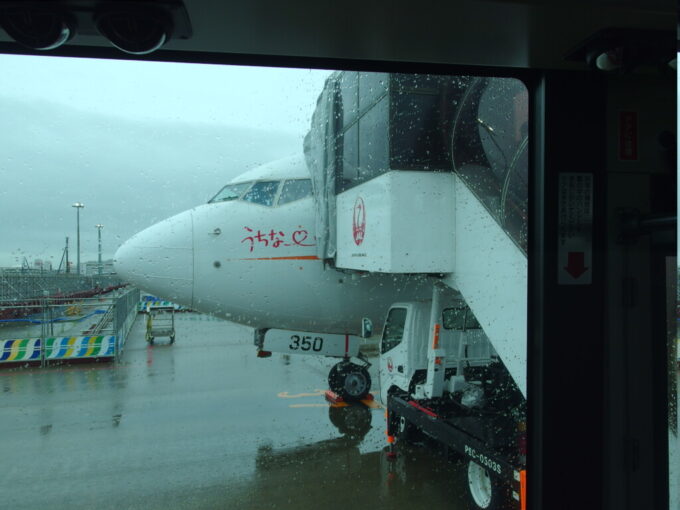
left=0, top=55, right=329, bottom=267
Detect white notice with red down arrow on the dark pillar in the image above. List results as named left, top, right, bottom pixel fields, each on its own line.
left=557, top=173, right=593, bottom=285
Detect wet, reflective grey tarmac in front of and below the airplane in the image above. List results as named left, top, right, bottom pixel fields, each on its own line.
left=0, top=313, right=476, bottom=510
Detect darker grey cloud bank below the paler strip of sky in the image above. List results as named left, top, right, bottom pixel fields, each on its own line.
left=0, top=96, right=302, bottom=266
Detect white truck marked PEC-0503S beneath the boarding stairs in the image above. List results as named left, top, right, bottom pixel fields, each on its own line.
left=379, top=285, right=526, bottom=510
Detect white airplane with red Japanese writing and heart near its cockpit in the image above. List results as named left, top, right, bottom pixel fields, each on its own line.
left=114, top=153, right=431, bottom=397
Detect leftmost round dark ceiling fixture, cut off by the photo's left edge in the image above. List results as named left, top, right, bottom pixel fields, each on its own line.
left=0, top=3, right=76, bottom=50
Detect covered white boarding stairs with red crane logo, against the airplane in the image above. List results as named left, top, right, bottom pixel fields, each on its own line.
left=305, top=72, right=528, bottom=395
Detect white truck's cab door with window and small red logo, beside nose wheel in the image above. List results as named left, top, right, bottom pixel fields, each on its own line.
left=379, top=307, right=409, bottom=404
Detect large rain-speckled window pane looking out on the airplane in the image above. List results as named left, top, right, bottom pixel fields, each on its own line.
left=0, top=56, right=527, bottom=510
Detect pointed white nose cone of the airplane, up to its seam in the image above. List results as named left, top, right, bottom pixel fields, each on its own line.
left=114, top=211, right=194, bottom=307
